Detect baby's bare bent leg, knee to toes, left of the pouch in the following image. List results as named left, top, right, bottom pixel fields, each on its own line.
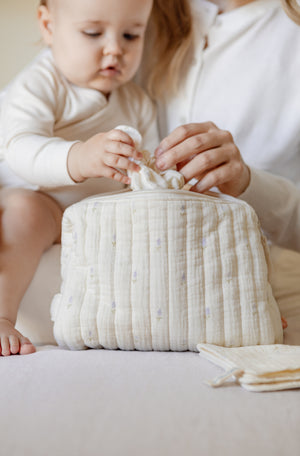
left=0, top=189, right=62, bottom=356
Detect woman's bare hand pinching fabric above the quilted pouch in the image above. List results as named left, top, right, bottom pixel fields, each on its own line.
left=155, top=122, right=250, bottom=196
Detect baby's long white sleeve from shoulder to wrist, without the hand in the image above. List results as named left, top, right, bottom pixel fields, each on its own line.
left=1, top=58, right=76, bottom=187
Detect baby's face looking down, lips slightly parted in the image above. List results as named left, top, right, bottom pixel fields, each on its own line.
left=39, top=0, right=153, bottom=94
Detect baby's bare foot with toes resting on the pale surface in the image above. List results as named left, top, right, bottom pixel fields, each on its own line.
left=0, top=318, right=36, bottom=356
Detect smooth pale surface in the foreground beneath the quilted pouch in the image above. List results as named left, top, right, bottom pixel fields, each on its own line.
left=0, top=347, right=300, bottom=456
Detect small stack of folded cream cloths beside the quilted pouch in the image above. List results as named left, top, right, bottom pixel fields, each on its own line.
left=197, top=344, right=300, bottom=391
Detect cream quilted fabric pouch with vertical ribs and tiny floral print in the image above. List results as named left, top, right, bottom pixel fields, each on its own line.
left=51, top=190, right=282, bottom=351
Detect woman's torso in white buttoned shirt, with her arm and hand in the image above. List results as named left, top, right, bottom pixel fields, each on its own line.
left=146, top=0, right=300, bottom=251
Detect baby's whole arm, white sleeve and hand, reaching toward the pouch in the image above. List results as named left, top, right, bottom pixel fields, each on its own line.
left=1, top=60, right=140, bottom=188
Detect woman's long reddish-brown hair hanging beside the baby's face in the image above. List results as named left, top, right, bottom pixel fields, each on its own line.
left=40, top=0, right=193, bottom=98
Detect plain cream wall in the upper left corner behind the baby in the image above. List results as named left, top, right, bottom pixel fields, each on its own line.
left=0, top=0, right=41, bottom=89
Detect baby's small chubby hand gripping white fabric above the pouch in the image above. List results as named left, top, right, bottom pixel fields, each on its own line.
left=67, top=130, right=142, bottom=184
